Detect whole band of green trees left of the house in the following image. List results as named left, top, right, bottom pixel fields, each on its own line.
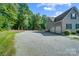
left=0, top=3, right=47, bottom=30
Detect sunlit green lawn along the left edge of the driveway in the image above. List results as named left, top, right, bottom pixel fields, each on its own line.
left=0, top=31, right=15, bottom=56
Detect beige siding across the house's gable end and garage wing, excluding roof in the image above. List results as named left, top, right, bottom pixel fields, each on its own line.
left=47, top=9, right=79, bottom=33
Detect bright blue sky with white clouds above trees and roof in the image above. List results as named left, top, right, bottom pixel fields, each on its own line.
left=28, top=3, right=79, bottom=17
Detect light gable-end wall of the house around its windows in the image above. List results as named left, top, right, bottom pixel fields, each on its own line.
left=62, top=9, right=79, bottom=32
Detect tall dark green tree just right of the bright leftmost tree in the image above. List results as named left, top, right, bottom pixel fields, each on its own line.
left=14, top=4, right=31, bottom=30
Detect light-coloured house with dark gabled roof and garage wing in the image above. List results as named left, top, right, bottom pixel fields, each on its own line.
left=46, top=7, right=79, bottom=33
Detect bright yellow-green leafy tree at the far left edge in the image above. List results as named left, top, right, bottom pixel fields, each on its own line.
left=0, top=4, right=16, bottom=29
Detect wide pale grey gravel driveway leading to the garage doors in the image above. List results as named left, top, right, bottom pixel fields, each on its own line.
left=15, top=31, right=79, bottom=56
